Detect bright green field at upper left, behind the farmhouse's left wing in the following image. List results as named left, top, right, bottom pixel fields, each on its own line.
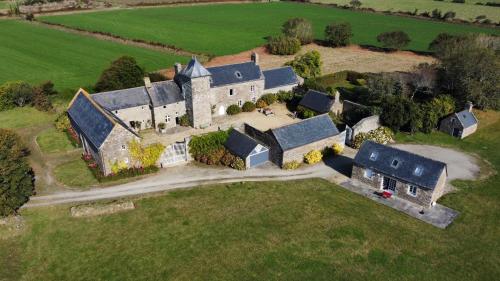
left=0, top=20, right=186, bottom=94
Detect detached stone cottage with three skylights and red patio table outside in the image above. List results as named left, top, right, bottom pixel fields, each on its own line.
left=351, top=141, right=448, bottom=207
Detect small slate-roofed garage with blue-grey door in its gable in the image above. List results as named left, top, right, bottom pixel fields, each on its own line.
left=224, top=130, right=269, bottom=166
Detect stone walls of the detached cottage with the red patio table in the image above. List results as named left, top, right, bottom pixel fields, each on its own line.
left=351, top=164, right=446, bottom=207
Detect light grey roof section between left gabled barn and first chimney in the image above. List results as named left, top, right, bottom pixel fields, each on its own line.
left=91, top=87, right=149, bottom=111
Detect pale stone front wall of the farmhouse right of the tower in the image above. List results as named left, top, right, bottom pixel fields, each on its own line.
left=210, top=80, right=264, bottom=116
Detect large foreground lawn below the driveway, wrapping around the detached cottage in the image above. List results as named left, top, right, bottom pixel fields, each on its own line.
left=0, top=112, right=500, bottom=281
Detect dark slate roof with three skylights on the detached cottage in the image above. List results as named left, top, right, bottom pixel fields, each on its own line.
left=354, top=141, right=446, bottom=190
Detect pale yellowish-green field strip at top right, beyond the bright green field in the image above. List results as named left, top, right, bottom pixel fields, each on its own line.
left=312, top=0, right=500, bottom=22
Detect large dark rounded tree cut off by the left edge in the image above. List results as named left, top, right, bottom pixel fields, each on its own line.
left=0, top=129, right=34, bottom=216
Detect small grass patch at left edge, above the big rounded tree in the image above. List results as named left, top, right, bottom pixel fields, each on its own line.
left=0, top=107, right=56, bottom=129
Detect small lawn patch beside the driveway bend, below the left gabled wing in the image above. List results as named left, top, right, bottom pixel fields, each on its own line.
left=53, top=158, right=99, bottom=187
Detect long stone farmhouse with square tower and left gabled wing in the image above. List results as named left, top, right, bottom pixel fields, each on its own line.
left=68, top=53, right=301, bottom=174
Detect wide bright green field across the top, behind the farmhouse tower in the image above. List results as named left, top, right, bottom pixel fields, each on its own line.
left=40, top=2, right=500, bottom=55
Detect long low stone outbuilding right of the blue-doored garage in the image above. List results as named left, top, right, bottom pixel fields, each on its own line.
left=245, top=114, right=345, bottom=167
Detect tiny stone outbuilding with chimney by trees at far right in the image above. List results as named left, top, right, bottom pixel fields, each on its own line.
left=439, top=102, right=478, bottom=139
